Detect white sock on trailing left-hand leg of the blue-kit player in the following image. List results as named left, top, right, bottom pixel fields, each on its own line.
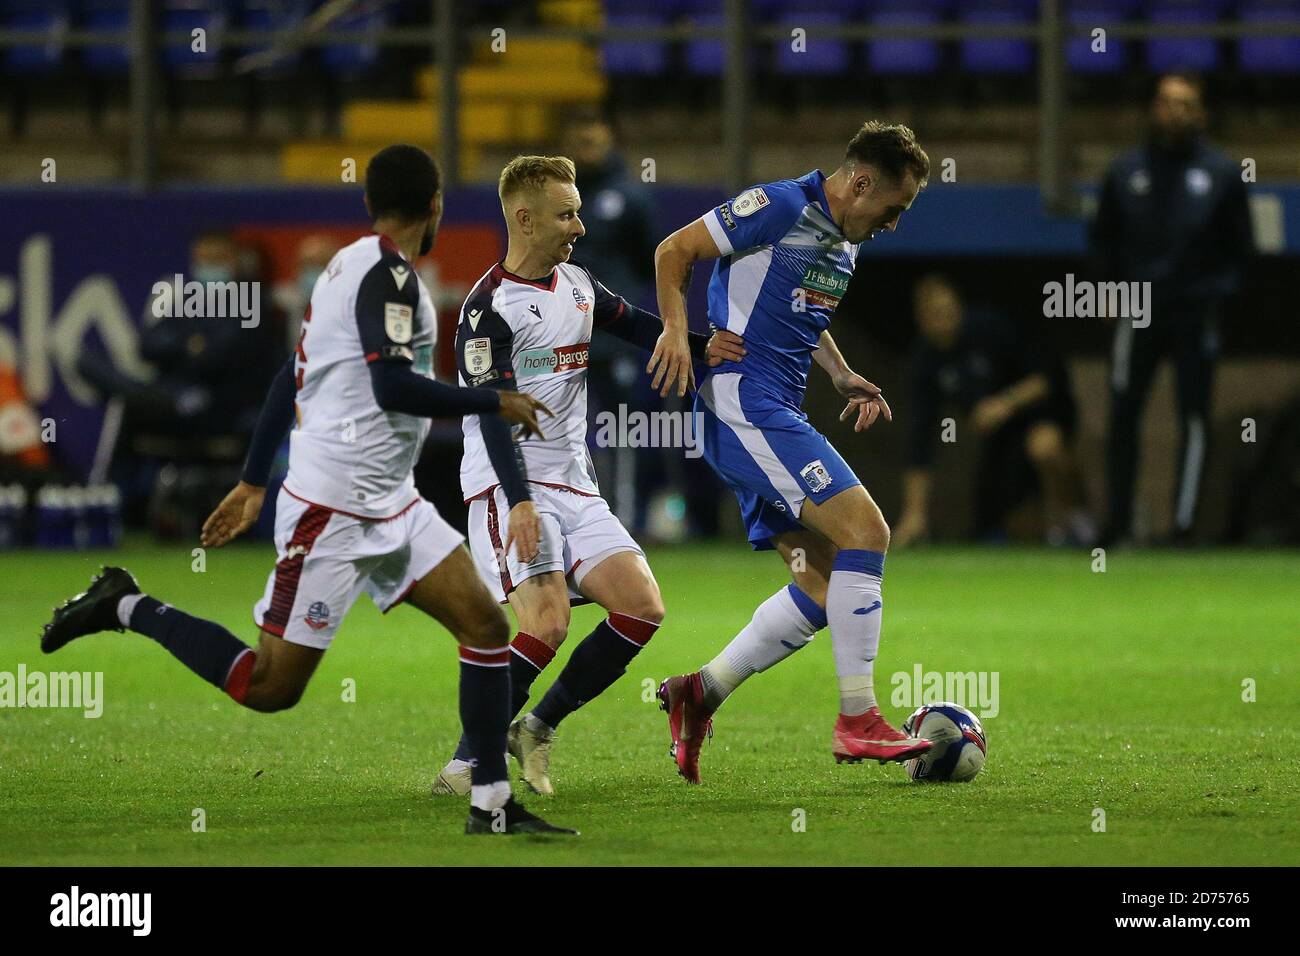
left=699, top=584, right=826, bottom=710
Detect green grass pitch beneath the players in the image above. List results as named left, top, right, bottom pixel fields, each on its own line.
left=0, top=541, right=1300, bottom=866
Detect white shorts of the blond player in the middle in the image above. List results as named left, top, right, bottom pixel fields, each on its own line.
left=469, top=483, right=644, bottom=604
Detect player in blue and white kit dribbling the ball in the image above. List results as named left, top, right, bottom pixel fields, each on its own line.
left=649, top=121, right=930, bottom=783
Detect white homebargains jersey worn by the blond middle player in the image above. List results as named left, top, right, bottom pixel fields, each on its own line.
left=456, top=263, right=625, bottom=501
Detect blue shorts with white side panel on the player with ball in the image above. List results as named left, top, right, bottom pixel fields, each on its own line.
left=696, top=372, right=862, bottom=550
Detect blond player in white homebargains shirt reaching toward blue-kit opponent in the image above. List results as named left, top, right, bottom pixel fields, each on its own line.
left=433, top=156, right=744, bottom=793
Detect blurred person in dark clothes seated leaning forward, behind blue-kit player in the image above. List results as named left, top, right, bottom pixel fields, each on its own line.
left=893, top=276, right=1095, bottom=545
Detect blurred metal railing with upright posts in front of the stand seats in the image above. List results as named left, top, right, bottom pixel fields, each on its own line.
left=0, top=0, right=1300, bottom=211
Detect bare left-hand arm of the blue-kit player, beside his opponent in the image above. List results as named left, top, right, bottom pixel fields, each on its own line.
left=646, top=212, right=722, bottom=397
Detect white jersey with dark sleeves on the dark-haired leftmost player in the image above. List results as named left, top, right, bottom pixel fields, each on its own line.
left=285, top=235, right=437, bottom=519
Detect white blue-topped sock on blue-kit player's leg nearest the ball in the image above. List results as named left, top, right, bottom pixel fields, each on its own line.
left=826, top=548, right=885, bottom=717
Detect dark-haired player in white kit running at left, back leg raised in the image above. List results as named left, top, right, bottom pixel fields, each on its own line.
left=42, top=146, right=573, bottom=834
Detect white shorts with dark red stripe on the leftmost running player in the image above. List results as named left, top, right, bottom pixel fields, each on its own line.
left=252, top=488, right=464, bottom=650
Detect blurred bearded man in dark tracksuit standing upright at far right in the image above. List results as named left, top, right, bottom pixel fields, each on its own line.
left=1091, top=74, right=1253, bottom=544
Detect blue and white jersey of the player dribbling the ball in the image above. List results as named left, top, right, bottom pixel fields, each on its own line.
left=703, top=169, right=858, bottom=408
